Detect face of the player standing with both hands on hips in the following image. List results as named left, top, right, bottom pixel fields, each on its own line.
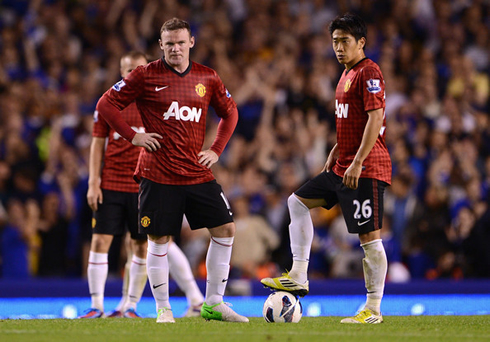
left=159, top=29, right=194, bottom=72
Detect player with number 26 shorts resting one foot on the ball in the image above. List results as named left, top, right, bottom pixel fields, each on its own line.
left=261, top=14, right=391, bottom=323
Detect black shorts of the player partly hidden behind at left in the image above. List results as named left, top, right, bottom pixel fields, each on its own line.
left=92, top=189, right=147, bottom=240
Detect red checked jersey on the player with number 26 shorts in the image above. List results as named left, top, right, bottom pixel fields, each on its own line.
left=333, top=58, right=391, bottom=184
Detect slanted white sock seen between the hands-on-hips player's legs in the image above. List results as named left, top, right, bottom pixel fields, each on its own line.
left=168, top=242, right=204, bottom=305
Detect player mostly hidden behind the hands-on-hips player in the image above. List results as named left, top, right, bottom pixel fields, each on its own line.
left=80, top=51, right=204, bottom=318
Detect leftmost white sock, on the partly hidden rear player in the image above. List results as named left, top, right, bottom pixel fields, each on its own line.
left=87, top=251, right=109, bottom=312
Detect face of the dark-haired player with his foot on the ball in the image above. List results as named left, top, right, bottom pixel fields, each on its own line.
left=332, top=30, right=366, bottom=69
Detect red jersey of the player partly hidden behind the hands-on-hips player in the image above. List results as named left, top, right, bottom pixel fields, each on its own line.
left=92, top=103, right=145, bottom=193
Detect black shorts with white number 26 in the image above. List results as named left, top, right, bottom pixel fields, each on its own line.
left=295, top=172, right=388, bottom=234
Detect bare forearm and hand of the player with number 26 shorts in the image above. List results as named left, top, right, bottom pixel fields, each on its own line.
left=343, top=108, right=384, bottom=189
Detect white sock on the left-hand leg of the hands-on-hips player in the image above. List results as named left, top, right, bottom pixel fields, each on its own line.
left=146, top=240, right=170, bottom=312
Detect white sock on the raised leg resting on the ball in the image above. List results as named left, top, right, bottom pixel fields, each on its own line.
left=288, top=194, right=314, bottom=283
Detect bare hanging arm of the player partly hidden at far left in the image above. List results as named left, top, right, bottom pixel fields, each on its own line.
left=87, top=137, right=105, bottom=211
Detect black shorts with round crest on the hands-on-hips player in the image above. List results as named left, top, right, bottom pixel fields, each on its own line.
left=139, top=178, right=233, bottom=236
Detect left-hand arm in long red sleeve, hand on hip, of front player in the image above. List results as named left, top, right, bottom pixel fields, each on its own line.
left=97, top=93, right=162, bottom=152
